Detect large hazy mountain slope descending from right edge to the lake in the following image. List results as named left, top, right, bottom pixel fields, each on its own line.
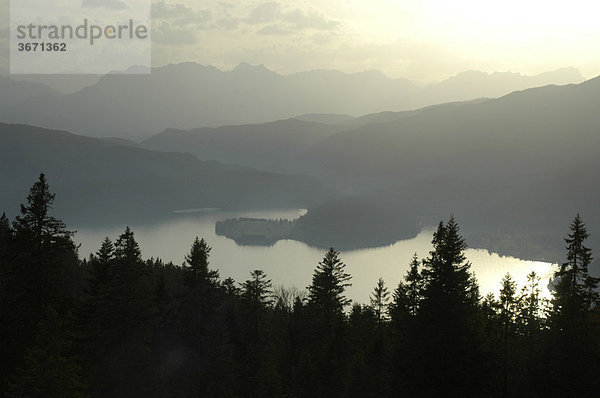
left=295, top=77, right=600, bottom=261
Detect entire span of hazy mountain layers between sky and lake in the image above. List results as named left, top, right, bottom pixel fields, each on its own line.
left=0, top=64, right=600, bottom=261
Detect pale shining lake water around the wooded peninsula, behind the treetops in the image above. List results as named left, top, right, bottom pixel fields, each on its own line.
left=75, top=209, right=553, bottom=303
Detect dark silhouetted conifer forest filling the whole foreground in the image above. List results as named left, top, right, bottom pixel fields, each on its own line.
left=0, top=174, right=600, bottom=397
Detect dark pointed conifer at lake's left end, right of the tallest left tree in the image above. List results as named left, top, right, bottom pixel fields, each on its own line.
left=85, top=227, right=158, bottom=396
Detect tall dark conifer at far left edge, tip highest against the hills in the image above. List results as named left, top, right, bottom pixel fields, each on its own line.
left=0, top=174, right=84, bottom=397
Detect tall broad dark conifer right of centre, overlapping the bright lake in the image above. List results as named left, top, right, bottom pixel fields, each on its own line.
left=415, top=217, right=484, bottom=396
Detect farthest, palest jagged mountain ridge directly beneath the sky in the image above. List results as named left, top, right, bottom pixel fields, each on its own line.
left=0, top=63, right=583, bottom=139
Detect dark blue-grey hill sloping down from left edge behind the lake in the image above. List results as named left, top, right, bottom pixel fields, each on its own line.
left=0, top=123, right=331, bottom=225
